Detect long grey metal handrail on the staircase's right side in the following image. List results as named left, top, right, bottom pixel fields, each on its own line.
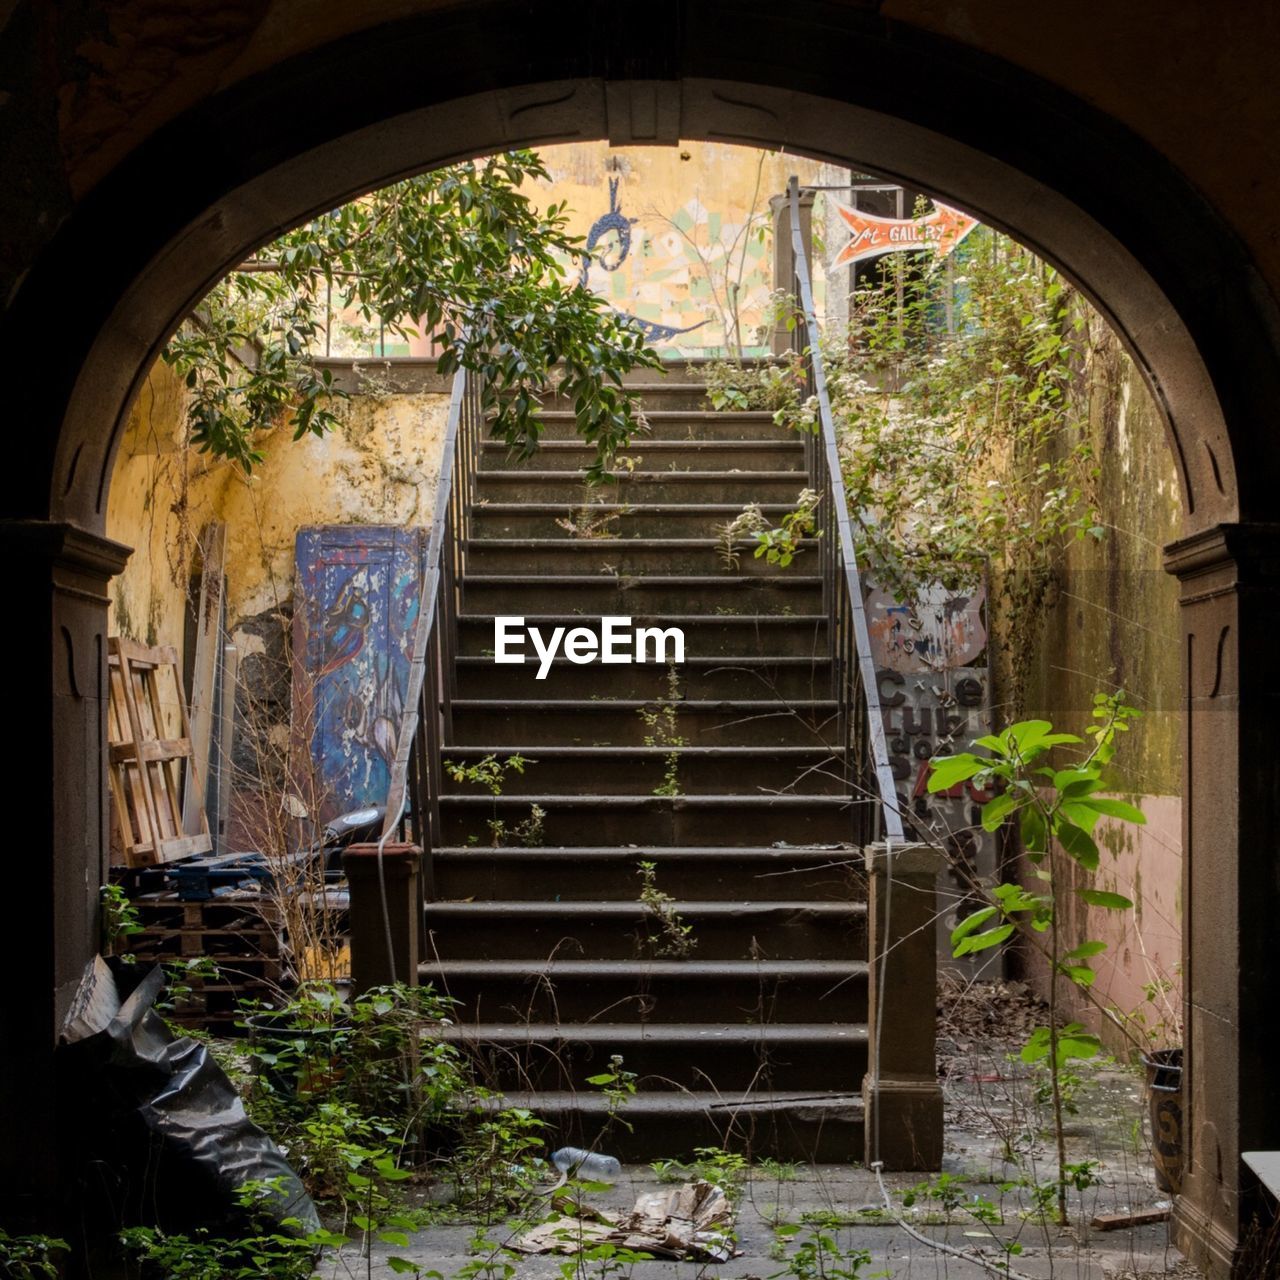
left=787, top=177, right=902, bottom=845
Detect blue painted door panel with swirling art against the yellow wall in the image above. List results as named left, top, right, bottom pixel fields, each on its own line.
left=293, top=525, right=426, bottom=822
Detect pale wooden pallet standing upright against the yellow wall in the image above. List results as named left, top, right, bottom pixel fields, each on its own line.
left=106, top=636, right=212, bottom=867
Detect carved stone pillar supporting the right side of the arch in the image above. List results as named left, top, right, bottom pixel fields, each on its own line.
left=1165, top=525, right=1280, bottom=1276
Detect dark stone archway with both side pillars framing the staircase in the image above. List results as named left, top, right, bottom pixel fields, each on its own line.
left=0, top=3, right=1280, bottom=1268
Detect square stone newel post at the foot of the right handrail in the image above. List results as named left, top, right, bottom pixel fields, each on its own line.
left=863, top=844, right=943, bottom=1170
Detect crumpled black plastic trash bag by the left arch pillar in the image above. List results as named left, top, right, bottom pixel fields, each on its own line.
left=60, top=956, right=320, bottom=1235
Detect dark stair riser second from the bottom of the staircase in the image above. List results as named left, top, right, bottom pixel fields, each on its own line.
left=440, top=1036, right=867, bottom=1093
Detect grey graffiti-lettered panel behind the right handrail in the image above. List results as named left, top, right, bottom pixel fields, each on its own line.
left=867, top=585, right=998, bottom=973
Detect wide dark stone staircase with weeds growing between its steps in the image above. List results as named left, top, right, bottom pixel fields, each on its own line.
left=421, top=372, right=867, bottom=1160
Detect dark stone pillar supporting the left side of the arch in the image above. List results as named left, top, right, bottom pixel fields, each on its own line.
left=0, top=521, right=129, bottom=1228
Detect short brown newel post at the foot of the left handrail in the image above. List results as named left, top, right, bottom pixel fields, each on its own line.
left=342, top=841, right=422, bottom=995
